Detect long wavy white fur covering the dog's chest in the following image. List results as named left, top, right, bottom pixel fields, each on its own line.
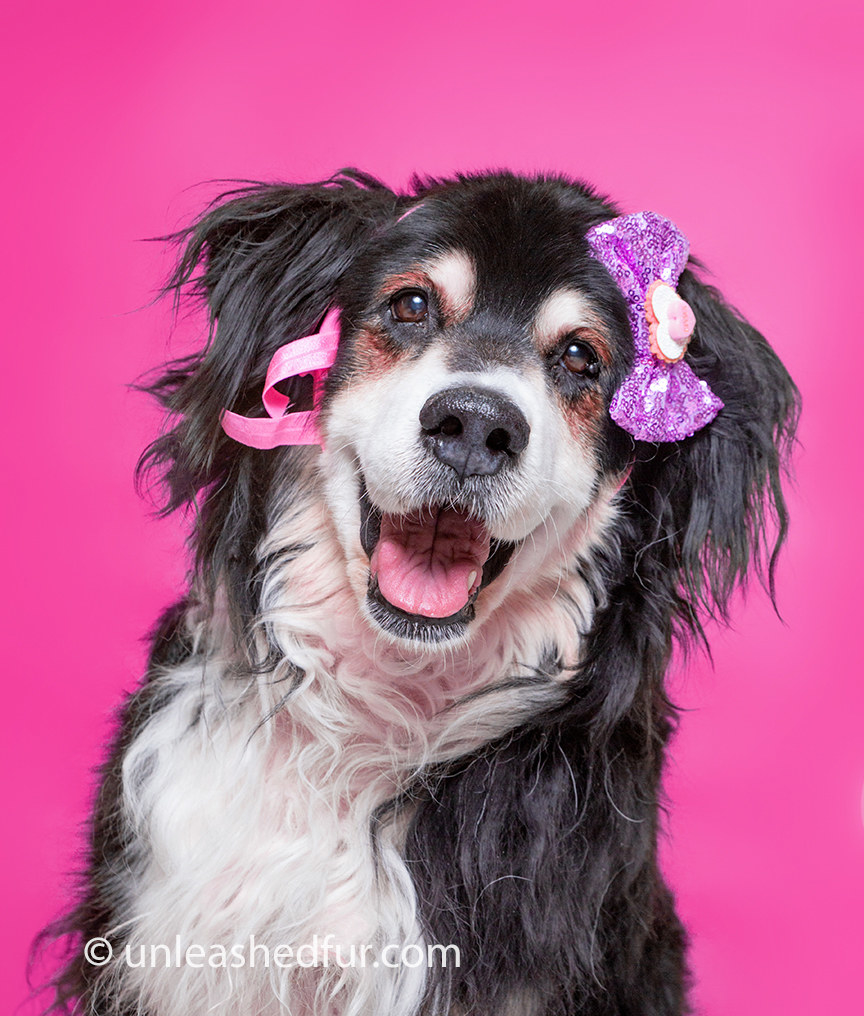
left=116, top=601, right=593, bottom=1016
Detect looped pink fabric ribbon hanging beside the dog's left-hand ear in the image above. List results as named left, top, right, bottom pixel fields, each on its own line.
left=222, top=307, right=341, bottom=448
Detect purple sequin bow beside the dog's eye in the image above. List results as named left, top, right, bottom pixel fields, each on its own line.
left=587, top=211, right=723, bottom=441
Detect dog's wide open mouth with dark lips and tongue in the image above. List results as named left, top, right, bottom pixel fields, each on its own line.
left=360, top=489, right=515, bottom=642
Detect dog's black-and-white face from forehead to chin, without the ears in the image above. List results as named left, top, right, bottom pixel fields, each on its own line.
left=322, top=181, right=632, bottom=646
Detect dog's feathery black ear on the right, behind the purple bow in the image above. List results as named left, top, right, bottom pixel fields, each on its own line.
left=630, top=262, right=800, bottom=627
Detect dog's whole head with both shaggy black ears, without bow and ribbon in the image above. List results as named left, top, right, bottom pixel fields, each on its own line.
left=141, top=167, right=796, bottom=647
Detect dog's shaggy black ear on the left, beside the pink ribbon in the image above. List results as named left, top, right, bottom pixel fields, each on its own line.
left=137, top=170, right=398, bottom=646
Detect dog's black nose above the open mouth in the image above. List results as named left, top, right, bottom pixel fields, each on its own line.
left=420, top=388, right=531, bottom=480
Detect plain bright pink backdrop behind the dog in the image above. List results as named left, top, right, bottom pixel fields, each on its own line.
left=0, top=0, right=864, bottom=1016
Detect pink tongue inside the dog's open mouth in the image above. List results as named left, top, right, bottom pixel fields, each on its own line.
left=371, top=508, right=489, bottom=618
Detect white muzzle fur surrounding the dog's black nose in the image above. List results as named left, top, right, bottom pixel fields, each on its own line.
left=320, top=331, right=603, bottom=650
